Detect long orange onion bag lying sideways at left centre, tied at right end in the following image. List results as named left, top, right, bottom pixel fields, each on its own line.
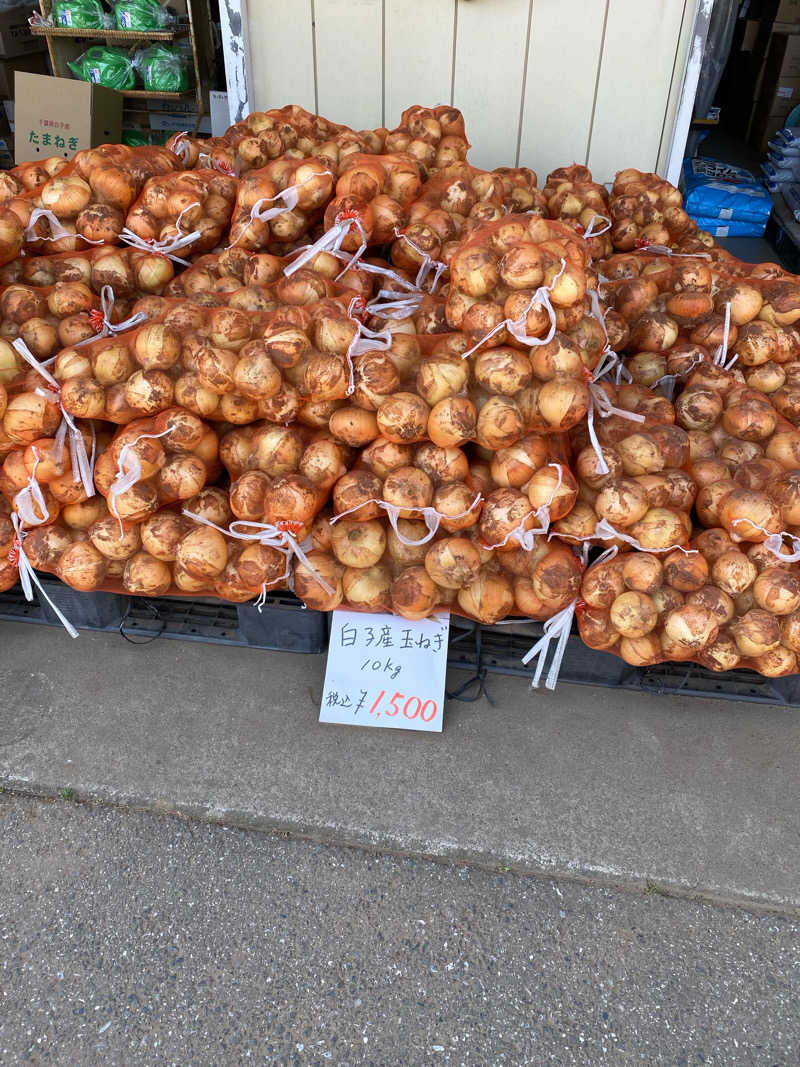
left=54, top=297, right=391, bottom=427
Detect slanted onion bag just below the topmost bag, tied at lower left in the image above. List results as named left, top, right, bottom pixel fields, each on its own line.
left=390, top=162, right=507, bottom=272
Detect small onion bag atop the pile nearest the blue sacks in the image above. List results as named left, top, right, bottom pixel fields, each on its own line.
left=608, top=168, right=698, bottom=252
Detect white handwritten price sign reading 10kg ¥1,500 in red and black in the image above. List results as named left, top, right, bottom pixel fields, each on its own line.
left=319, top=610, right=450, bottom=733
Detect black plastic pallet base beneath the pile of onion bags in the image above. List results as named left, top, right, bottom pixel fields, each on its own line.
left=0, top=579, right=800, bottom=707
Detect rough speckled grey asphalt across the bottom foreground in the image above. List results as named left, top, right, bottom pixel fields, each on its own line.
left=0, top=795, right=800, bottom=1067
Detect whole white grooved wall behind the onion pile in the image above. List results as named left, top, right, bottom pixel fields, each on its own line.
left=247, top=0, right=695, bottom=181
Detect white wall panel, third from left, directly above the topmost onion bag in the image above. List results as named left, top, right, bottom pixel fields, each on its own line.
left=384, top=0, right=458, bottom=129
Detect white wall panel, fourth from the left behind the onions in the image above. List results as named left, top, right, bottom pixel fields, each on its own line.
left=452, top=0, right=534, bottom=168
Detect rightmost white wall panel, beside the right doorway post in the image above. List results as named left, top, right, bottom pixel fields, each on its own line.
left=589, top=0, right=684, bottom=181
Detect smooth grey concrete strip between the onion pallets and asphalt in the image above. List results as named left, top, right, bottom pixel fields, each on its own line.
left=0, top=623, right=800, bottom=910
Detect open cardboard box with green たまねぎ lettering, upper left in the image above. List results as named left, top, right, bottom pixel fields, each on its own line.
left=14, top=71, right=123, bottom=163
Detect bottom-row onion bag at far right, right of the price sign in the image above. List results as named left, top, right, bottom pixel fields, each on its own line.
left=576, top=537, right=800, bottom=678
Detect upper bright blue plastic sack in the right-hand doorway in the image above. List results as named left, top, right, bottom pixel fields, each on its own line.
left=684, top=157, right=772, bottom=223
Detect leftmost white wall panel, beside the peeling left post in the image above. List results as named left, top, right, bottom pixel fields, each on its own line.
left=247, top=0, right=315, bottom=111
